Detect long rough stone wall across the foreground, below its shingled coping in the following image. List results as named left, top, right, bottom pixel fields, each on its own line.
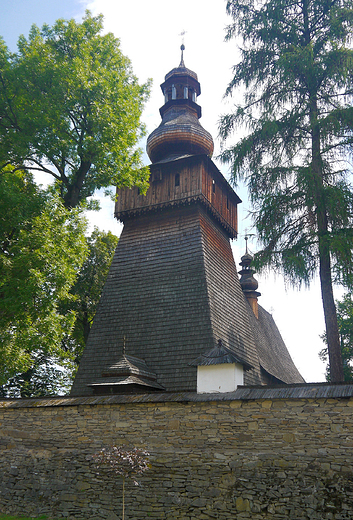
left=0, top=394, right=353, bottom=520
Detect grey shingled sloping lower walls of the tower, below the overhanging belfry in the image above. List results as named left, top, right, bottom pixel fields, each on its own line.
left=72, top=204, right=261, bottom=395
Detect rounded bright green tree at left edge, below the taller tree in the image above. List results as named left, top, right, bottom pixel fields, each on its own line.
left=0, top=170, right=87, bottom=384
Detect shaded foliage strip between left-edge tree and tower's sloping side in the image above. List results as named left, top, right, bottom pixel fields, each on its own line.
left=0, top=221, right=118, bottom=397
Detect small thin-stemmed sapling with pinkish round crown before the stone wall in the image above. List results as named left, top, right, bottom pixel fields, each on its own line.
left=92, top=446, right=149, bottom=520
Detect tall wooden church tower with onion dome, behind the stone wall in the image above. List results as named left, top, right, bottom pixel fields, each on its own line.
left=71, top=46, right=303, bottom=395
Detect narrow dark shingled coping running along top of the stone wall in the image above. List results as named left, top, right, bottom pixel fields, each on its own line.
left=0, top=383, right=353, bottom=408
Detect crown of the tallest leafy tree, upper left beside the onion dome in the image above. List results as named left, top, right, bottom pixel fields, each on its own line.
left=0, top=12, right=149, bottom=207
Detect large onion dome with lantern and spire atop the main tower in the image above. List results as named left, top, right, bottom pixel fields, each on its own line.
left=147, top=45, right=213, bottom=163
